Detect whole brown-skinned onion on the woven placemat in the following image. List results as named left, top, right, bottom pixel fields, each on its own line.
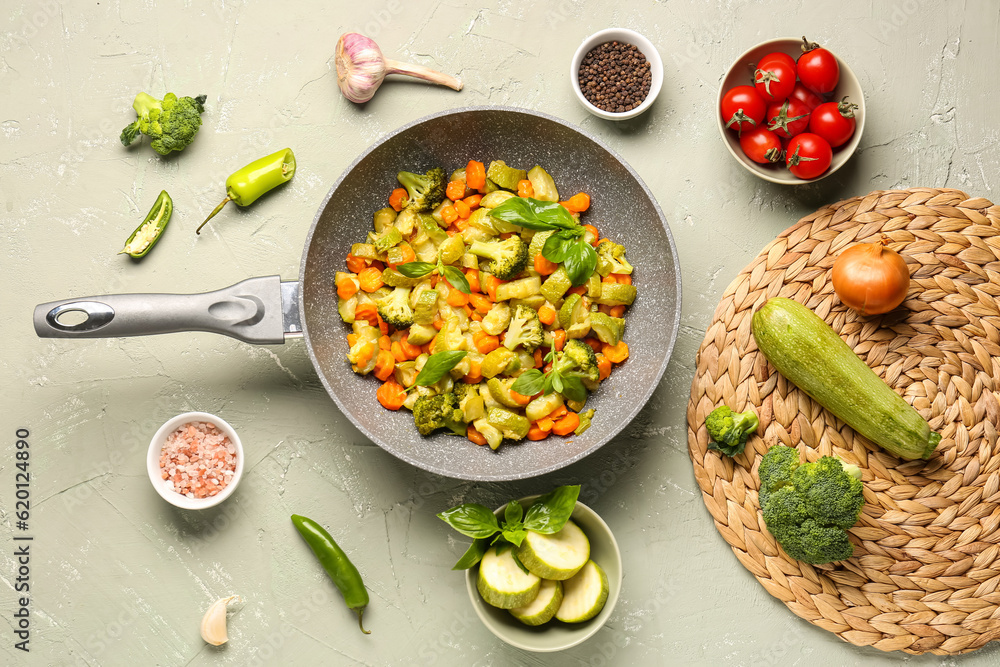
left=831, top=236, right=910, bottom=315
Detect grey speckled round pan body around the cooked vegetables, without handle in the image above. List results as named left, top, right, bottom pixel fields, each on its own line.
left=300, top=107, right=681, bottom=481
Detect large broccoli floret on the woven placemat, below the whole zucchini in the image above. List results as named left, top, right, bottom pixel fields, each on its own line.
left=758, top=445, right=865, bottom=565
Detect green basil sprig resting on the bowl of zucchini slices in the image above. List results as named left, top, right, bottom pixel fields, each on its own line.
left=438, top=484, right=580, bottom=570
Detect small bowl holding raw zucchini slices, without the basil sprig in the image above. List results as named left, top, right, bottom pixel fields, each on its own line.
left=465, top=494, right=622, bottom=652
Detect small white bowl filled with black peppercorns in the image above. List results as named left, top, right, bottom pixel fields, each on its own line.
left=570, top=28, right=663, bottom=120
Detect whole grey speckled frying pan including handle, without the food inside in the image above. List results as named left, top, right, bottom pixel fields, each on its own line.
left=34, top=107, right=681, bottom=481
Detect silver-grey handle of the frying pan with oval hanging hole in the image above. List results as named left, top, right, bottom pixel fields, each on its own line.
left=34, top=276, right=285, bottom=345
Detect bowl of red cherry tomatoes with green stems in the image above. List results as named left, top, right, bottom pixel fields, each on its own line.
left=716, top=38, right=865, bottom=185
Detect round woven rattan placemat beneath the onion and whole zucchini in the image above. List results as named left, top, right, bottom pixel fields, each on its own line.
left=687, top=188, right=1000, bottom=655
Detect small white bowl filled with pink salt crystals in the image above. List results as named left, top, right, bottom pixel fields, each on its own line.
left=146, top=412, right=243, bottom=510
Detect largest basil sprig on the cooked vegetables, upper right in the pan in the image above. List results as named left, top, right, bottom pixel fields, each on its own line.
left=490, top=197, right=597, bottom=287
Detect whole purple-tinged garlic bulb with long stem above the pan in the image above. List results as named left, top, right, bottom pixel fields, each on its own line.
left=336, top=32, right=462, bottom=103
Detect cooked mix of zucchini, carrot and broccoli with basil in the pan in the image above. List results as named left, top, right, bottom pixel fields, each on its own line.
left=344, top=160, right=637, bottom=449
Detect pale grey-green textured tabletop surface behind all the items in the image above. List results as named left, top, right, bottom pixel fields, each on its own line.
left=0, top=0, right=1000, bottom=666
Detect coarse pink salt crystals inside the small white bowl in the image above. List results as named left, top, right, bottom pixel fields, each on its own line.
left=160, top=422, right=236, bottom=498
